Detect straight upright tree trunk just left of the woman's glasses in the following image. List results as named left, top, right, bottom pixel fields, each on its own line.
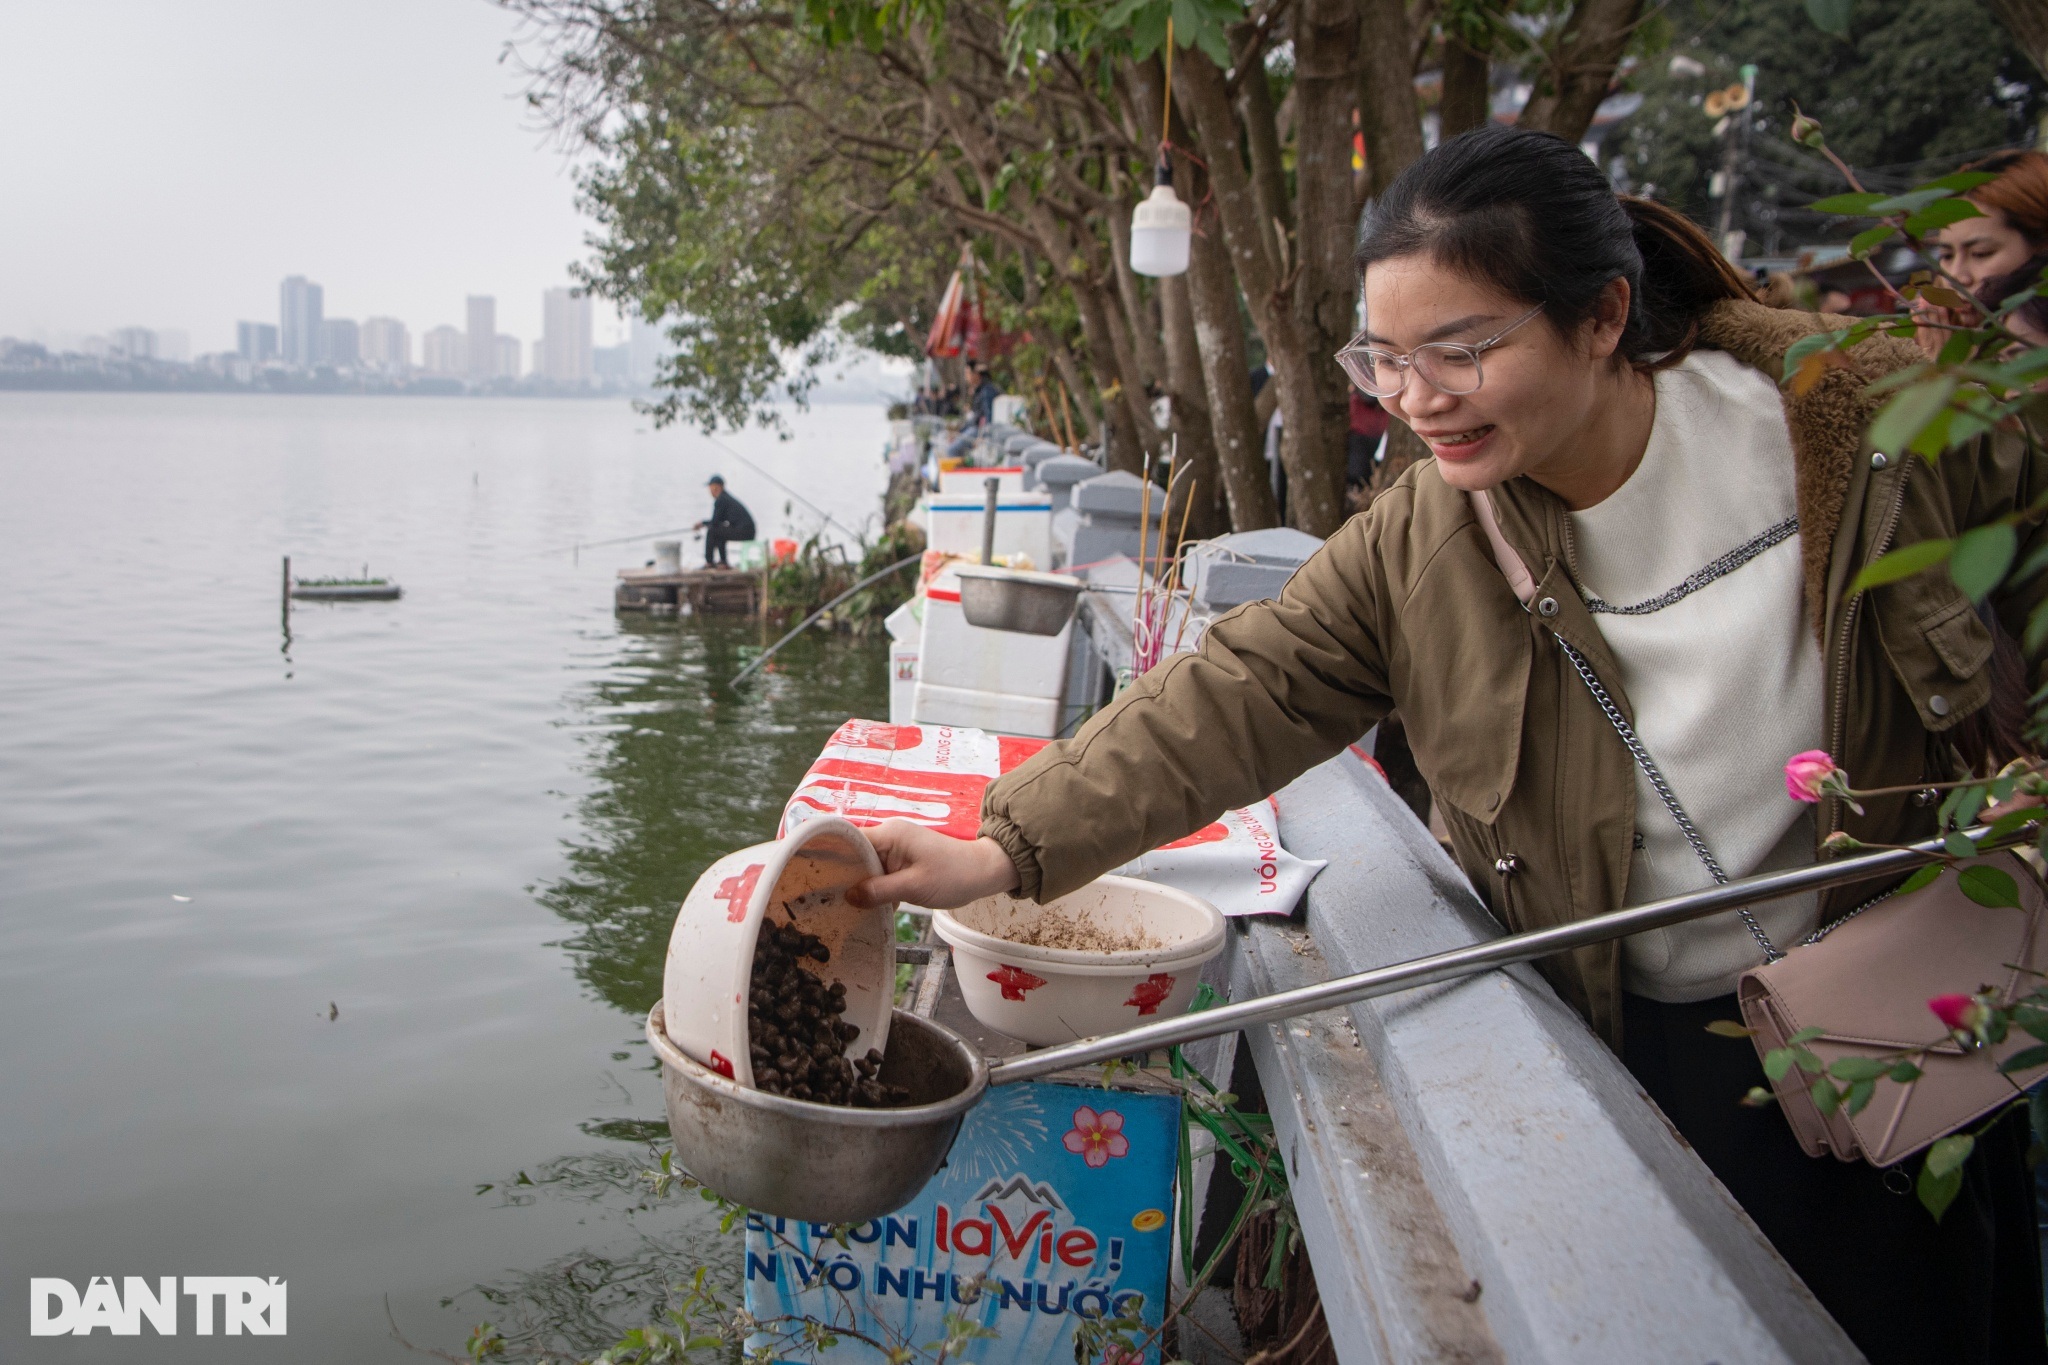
left=1282, top=0, right=1360, bottom=536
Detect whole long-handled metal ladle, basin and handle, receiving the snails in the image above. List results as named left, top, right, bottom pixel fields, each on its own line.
left=647, top=829, right=2019, bottom=1224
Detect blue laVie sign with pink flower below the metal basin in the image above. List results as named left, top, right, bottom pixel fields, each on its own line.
left=745, top=1085, right=1180, bottom=1365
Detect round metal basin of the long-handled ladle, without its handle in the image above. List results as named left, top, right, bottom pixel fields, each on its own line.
left=647, top=1003, right=989, bottom=1224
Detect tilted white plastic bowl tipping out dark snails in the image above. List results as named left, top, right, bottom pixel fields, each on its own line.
left=662, top=817, right=895, bottom=1087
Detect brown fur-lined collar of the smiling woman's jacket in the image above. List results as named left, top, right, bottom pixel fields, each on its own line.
left=1700, top=299, right=1923, bottom=630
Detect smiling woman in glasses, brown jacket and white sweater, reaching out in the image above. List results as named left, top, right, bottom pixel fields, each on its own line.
left=847, top=127, right=2048, bottom=1361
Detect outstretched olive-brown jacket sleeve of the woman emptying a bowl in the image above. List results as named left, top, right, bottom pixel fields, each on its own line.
left=981, top=499, right=1393, bottom=900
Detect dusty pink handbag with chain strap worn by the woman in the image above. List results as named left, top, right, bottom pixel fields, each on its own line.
left=1468, top=493, right=2048, bottom=1166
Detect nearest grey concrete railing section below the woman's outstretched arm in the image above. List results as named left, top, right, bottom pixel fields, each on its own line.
left=1229, top=753, right=1862, bottom=1365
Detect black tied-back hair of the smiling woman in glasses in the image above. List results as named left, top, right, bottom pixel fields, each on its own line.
left=1358, top=125, right=1755, bottom=370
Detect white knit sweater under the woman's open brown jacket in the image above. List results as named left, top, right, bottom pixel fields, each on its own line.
left=1571, top=352, right=1825, bottom=1001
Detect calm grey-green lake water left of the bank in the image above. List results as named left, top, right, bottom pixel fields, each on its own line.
left=0, top=393, right=887, bottom=1365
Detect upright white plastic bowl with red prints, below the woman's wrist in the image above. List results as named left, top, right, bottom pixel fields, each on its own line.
left=932, top=876, right=1223, bottom=1046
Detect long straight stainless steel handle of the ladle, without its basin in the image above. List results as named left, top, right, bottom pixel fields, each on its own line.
left=989, top=827, right=1990, bottom=1085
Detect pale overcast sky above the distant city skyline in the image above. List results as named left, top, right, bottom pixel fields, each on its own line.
left=0, top=0, right=616, bottom=354
